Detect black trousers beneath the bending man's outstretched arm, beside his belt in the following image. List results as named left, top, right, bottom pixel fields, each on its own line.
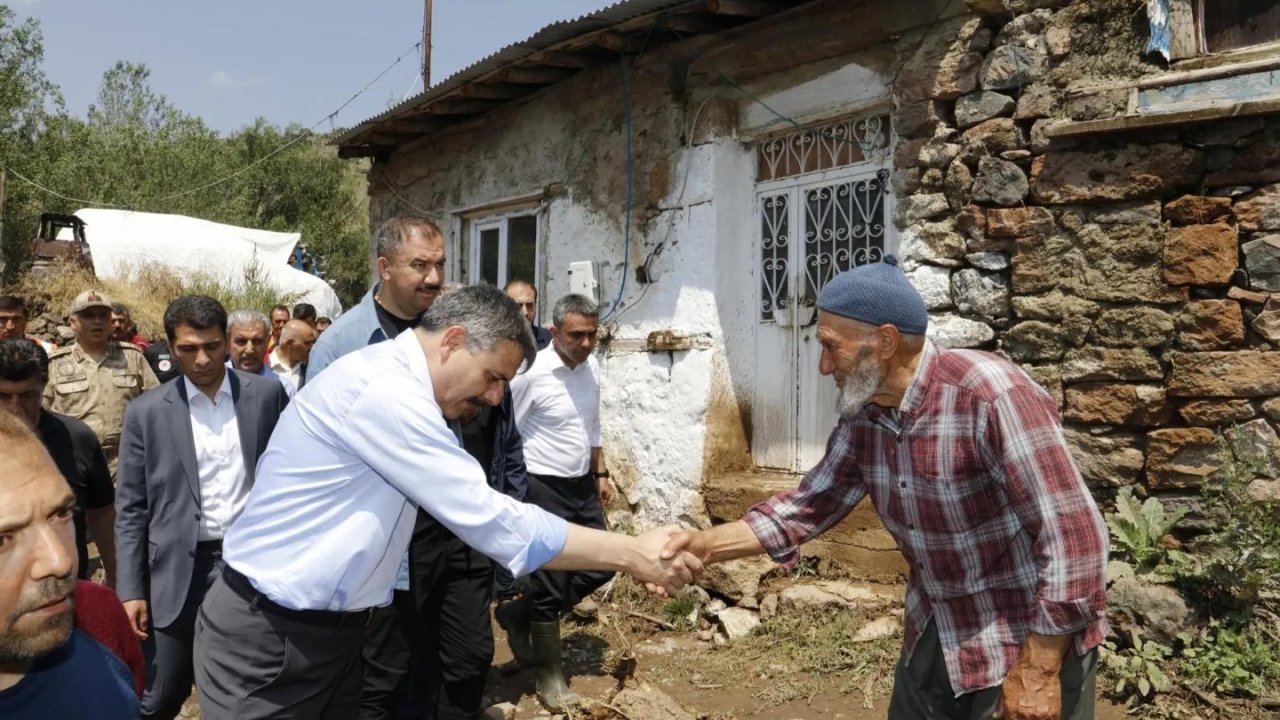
left=360, top=512, right=493, bottom=720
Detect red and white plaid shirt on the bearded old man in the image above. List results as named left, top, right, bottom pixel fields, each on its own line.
left=745, top=342, right=1108, bottom=697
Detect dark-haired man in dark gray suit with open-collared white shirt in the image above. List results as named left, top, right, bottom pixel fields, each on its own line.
left=115, top=296, right=288, bottom=720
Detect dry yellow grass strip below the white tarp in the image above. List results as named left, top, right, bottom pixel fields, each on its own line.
left=9, top=258, right=297, bottom=337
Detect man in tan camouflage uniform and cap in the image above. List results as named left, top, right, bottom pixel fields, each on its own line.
left=45, top=290, right=160, bottom=482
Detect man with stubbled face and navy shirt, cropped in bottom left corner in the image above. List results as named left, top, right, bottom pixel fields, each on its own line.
left=0, top=413, right=141, bottom=720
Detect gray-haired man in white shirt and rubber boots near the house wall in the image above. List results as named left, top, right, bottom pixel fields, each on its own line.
left=498, top=295, right=613, bottom=710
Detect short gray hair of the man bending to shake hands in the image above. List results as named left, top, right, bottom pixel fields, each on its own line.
left=417, top=284, right=538, bottom=366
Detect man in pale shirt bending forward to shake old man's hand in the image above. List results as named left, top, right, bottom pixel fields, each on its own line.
left=196, top=286, right=701, bottom=720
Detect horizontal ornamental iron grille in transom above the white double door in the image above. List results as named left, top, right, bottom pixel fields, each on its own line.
left=755, top=115, right=888, bottom=182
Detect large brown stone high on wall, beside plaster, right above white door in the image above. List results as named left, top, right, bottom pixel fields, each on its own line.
left=893, top=17, right=983, bottom=101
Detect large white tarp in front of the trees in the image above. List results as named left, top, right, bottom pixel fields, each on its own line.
left=64, top=209, right=342, bottom=318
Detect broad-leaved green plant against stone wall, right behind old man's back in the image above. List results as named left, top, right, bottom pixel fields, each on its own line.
left=1106, top=488, right=1192, bottom=582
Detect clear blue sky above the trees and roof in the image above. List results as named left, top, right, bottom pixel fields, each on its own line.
left=18, top=0, right=612, bottom=132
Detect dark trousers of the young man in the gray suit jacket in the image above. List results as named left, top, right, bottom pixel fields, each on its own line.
left=142, top=542, right=223, bottom=720
